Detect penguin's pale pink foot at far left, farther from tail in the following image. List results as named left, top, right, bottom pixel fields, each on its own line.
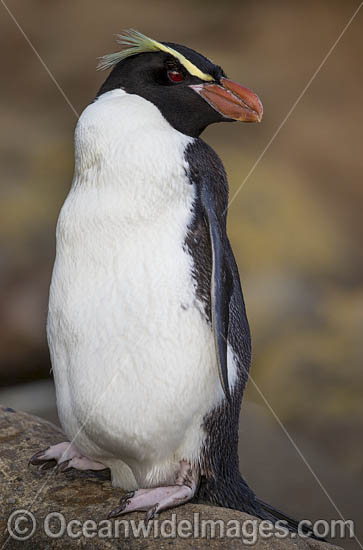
left=29, top=441, right=107, bottom=473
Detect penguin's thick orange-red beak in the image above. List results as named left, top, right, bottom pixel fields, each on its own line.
left=190, top=78, right=263, bottom=122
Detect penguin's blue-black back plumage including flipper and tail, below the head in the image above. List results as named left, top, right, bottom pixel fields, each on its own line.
left=185, top=139, right=326, bottom=538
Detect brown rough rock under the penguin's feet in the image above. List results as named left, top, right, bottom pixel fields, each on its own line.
left=0, top=407, right=338, bottom=550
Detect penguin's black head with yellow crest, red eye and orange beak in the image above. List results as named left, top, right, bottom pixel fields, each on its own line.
left=97, top=30, right=263, bottom=137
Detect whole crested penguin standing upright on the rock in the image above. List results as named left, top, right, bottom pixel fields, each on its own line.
left=30, top=30, right=308, bottom=529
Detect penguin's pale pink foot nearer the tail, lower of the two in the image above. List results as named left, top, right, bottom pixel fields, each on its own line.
left=108, top=461, right=199, bottom=521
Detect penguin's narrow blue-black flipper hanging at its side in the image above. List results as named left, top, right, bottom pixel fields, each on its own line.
left=200, top=182, right=233, bottom=401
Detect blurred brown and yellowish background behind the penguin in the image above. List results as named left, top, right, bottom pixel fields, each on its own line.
left=0, top=0, right=363, bottom=548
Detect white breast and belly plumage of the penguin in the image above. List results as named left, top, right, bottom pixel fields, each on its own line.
left=48, top=90, right=236, bottom=489
